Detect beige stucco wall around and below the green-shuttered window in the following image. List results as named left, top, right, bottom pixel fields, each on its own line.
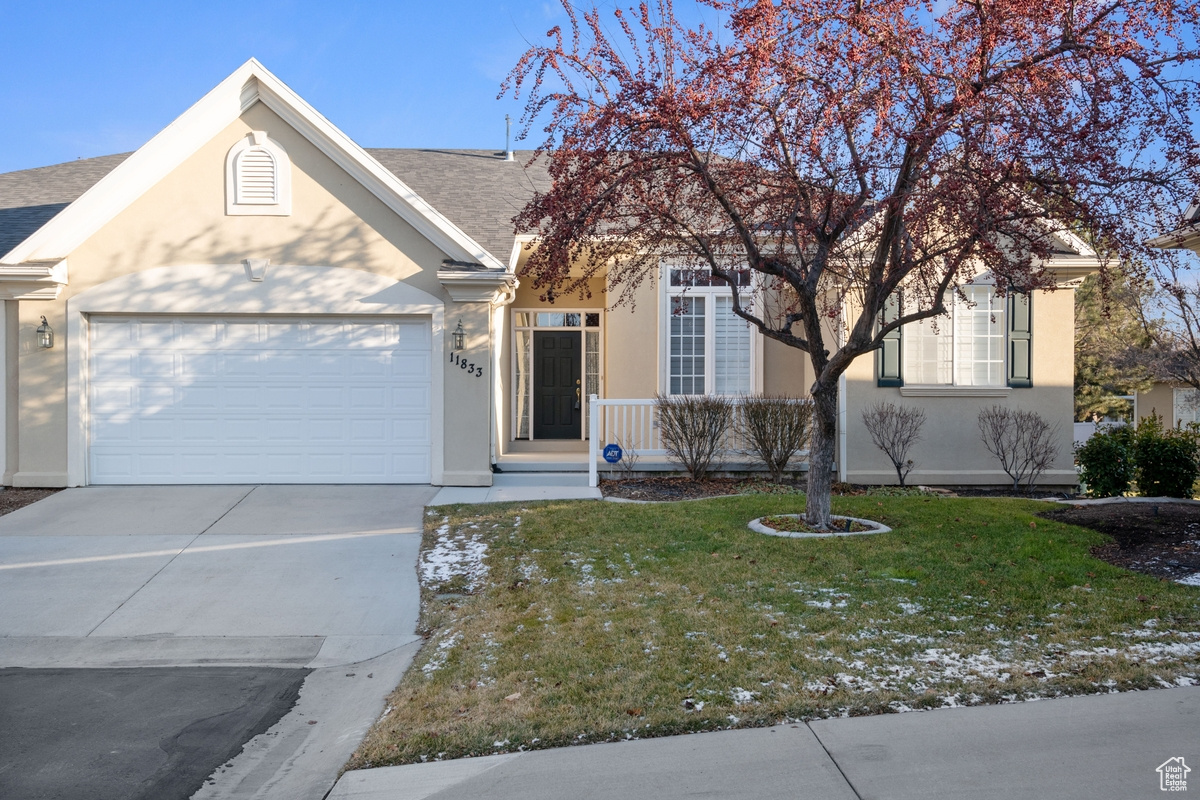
left=846, top=288, right=1075, bottom=486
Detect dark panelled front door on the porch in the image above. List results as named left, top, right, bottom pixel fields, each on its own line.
left=533, top=331, right=583, bottom=439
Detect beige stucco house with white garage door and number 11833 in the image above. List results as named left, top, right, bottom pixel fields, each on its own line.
left=0, top=60, right=1097, bottom=486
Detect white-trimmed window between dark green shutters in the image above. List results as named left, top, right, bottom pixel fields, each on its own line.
left=902, top=285, right=1006, bottom=386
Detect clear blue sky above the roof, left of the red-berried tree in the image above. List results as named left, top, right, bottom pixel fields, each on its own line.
left=0, top=0, right=590, bottom=172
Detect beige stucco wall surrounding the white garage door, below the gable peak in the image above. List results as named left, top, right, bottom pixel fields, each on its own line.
left=10, top=103, right=491, bottom=486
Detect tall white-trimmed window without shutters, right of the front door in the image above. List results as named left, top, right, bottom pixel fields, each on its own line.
left=664, top=267, right=755, bottom=395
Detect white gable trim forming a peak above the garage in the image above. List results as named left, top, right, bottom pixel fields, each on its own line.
left=0, top=59, right=504, bottom=270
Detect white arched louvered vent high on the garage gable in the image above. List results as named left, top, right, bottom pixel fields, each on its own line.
left=226, top=131, right=292, bottom=216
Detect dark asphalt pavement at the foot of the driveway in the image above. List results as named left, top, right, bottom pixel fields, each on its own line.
left=0, top=667, right=311, bottom=800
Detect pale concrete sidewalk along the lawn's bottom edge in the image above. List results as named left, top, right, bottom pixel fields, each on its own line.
left=329, top=687, right=1200, bottom=800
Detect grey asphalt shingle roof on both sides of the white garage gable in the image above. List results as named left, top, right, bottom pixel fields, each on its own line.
left=0, top=149, right=550, bottom=264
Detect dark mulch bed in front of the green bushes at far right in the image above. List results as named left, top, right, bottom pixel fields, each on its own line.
left=1042, top=503, right=1200, bottom=581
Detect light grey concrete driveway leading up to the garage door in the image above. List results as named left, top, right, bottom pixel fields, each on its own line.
left=0, top=486, right=433, bottom=798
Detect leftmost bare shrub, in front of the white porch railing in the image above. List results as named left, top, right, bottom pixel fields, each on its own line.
left=654, top=395, right=733, bottom=481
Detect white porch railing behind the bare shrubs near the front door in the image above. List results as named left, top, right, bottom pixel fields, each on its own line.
left=588, top=395, right=808, bottom=487
